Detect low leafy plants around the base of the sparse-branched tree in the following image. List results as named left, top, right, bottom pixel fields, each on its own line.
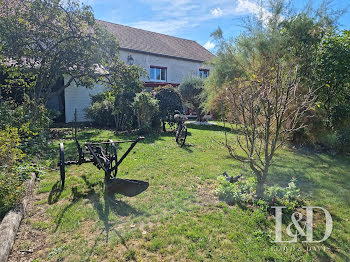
left=216, top=175, right=300, bottom=211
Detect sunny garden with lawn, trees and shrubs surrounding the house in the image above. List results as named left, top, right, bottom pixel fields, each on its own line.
left=0, top=0, right=350, bottom=261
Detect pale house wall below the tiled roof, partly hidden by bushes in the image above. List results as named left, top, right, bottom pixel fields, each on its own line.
left=65, top=50, right=210, bottom=123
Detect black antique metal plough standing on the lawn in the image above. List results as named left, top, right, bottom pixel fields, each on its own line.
left=58, top=129, right=149, bottom=196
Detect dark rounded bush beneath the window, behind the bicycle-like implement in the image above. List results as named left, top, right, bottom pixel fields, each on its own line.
left=155, top=85, right=183, bottom=132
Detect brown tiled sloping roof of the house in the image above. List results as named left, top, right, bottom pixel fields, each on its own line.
left=97, top=20, right=214, bottom=62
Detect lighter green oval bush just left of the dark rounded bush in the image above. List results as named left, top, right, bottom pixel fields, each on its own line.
left=133, top=92, right=159, bottom=131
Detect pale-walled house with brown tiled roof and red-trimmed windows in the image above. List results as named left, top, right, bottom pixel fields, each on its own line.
left=64, top=20, right=214, bottom=123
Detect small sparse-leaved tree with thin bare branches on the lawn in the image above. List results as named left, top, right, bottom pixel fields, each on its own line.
left=225, top=64, right=314, bottom=198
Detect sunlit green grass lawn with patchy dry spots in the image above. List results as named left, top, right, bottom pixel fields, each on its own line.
left=10, top=125, right=350, bottom=261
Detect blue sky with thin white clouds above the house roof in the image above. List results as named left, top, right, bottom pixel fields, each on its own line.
left=81, top=0, right=350, bottom=52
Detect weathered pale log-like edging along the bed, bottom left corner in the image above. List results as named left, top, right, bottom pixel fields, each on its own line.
left=0, top=173, right=36, bottom=262
